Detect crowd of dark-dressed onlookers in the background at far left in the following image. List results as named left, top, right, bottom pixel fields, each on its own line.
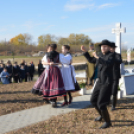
left=0, top=60, right=35, bottom=84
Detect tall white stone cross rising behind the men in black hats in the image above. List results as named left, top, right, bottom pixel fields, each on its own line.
left=112, top=23, right=126, bottom=54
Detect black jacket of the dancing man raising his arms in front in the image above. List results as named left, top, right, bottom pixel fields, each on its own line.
left=83, top=51, right=115, bottom=84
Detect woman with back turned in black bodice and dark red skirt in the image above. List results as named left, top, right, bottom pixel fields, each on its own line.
left=32, top=44, right=66, bottom=107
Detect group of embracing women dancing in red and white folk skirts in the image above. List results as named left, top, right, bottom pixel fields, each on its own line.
left=32, top=44, right=79, bottom=107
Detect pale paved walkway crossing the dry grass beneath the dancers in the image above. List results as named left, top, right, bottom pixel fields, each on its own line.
left=0, top=90, right=91, bottom=134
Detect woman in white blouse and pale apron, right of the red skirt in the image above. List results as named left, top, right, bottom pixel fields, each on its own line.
left=60, top=45, right=76, bottom=106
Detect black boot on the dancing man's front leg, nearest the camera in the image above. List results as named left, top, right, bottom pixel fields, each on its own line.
left=100, top=109, right=112, bottom=129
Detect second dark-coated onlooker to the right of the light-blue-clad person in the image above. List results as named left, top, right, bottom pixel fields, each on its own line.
left=13, top=62, right=20, bottom=83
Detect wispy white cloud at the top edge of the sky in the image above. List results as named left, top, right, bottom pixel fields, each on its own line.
left=64, top=0, right=119, bottom=11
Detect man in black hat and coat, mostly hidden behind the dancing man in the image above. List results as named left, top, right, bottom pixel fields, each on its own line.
left=110, top=42, right=122, bottom=111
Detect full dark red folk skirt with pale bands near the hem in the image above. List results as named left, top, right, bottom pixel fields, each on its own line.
left=32, top=66, right=66, bottom=99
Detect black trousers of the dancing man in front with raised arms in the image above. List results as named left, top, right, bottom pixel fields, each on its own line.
left=90, top=79, right=112, bottom=110
